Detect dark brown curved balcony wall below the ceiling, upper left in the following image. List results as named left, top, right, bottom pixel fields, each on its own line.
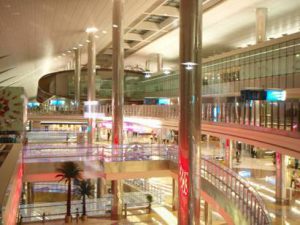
left=37, top=69, right=144, bottom=102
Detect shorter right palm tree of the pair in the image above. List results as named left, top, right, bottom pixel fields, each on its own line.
left=75, top=180, right=95, bottom=221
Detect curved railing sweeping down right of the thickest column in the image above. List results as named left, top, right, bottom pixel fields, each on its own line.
left=201, top=158, right=271, bottom=225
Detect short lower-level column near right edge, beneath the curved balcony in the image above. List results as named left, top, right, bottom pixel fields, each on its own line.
left=275, top=152, right=287, bottom=203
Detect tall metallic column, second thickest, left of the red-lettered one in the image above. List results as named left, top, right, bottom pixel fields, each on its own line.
left=111, top=0, right=124, bottom=219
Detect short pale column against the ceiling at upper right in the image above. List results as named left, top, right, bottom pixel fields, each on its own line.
left=256, top=8, right=268, bottom=43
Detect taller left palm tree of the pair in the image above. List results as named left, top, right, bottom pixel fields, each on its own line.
left=56, top=162, right=82, bottom=223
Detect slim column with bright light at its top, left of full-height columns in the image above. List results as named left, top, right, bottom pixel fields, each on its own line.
left=87, top=32, right=96, bottom=144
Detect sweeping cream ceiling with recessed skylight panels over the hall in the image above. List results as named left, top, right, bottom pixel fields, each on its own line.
left=0, top=0, right=300, bottom=97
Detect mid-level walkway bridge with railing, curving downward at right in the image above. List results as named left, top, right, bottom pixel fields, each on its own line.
left=24, top=145, right=271, bottom=225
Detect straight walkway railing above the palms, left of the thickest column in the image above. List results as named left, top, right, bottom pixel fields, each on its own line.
left=23, top=144, right=176, bottom=163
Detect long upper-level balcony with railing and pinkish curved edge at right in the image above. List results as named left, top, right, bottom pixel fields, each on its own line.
left=28, top=103, right=300, bottom=157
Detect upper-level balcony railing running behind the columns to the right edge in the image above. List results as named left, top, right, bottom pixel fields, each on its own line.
left=29, top=101, right=300, bottom=135
